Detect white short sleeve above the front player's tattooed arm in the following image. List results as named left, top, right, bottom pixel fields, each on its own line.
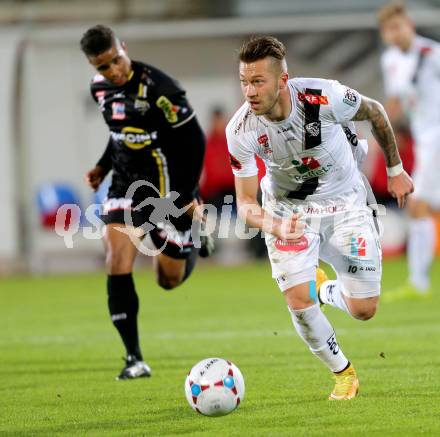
left=327, top=81, right=361, bottom=123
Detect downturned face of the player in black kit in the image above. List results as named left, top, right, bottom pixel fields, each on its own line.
left=89, top=41, right=131, bottom=86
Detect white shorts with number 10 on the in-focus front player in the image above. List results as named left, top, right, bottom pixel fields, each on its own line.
left=263, top=179, right=382, bottom=299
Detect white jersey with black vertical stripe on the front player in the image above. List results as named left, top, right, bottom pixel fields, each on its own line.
left=226, top=78, right=361, bottom=200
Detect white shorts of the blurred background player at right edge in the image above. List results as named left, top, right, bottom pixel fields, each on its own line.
left=412, top=130, right=440, bottom=210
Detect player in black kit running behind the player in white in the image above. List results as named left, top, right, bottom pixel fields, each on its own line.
left=80, top=25, right=213, bottom=379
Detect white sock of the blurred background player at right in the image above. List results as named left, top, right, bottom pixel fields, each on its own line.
left=408, top=218, right=435, bottom=291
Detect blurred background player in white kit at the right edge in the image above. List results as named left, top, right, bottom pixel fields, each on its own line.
left=378, top=3, right=440, bottom=301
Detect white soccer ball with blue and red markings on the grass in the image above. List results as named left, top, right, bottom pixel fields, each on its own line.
left=185, top=358, right=244, bottom=416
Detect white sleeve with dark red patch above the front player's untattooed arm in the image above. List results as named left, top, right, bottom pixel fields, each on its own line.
left=226, top=126, right=258, bottom=178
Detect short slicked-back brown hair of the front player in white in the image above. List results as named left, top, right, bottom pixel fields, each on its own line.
left=238, top=35, right=286, bottom=64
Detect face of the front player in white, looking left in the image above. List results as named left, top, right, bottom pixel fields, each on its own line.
left=240, top=58, right=282, bottom=115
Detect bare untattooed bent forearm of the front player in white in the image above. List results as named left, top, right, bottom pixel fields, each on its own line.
left=235, top=176, right=304, bottom=240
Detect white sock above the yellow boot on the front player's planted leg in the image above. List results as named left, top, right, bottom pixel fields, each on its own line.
left=289, top=304, right=348, bottom=372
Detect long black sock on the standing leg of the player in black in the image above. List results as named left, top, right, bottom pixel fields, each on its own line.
left=107, top=273, right=142, bottom=360
